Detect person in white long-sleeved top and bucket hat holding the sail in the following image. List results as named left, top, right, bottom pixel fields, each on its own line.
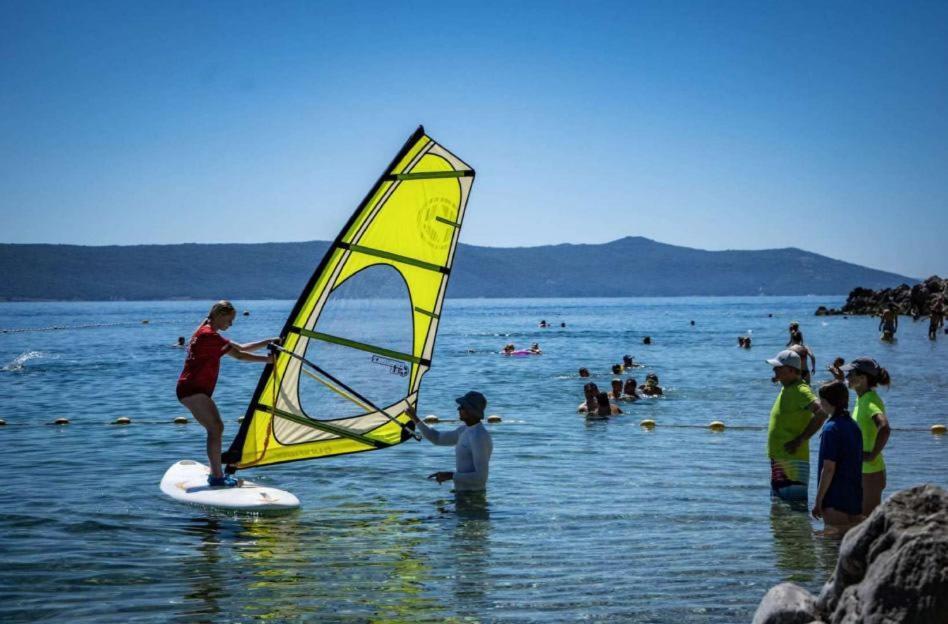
left=408, top=391, right=494, bottom=492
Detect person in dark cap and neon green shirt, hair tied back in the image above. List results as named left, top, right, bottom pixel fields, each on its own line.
left=842, top=358, right=891, bottom=516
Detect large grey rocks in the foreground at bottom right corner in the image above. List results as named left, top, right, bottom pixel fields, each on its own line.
left=754, top=485, right=948, bottom=624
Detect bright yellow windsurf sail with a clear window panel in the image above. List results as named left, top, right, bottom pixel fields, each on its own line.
left=223, top=127, right=474, bottom=470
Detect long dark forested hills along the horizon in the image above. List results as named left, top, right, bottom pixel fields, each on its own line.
left=0, top=237, right=918, bottom=301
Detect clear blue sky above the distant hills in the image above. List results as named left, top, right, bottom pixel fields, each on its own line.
left=0, top=0, right=948, bottom=276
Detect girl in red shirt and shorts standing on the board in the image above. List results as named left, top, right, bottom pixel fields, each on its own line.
left=176, top=301, right=280, bottom=487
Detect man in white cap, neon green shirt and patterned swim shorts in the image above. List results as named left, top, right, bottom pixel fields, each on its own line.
left=767, top=349, right=827, bottom=504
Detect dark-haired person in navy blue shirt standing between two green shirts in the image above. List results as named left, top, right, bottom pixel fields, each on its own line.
left=812, top=381, right=863, bottom=530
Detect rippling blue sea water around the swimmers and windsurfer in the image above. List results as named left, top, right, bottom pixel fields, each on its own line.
left=0, top=297, right=948, bottom=624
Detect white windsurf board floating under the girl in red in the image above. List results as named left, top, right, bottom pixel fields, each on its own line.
left=161, top=459, right=300, bottom=512
